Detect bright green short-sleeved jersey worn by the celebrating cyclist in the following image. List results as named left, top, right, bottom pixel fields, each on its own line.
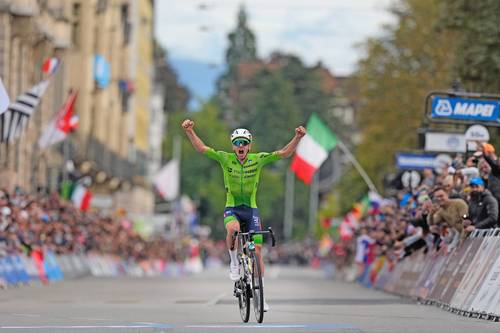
left=205, top=148, right=281, bottom=208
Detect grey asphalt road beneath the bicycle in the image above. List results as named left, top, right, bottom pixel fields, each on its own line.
left=0, top=267, right=500, bottom=333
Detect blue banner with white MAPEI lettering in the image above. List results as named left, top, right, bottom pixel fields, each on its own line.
left=431, top=96, right=500, bottom=123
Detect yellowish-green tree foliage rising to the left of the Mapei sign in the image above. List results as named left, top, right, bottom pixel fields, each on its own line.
left=338, top=0, right=453, bottom=200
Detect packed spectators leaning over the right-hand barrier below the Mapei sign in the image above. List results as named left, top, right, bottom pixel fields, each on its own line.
left=350, top=142, right=500, bottom=276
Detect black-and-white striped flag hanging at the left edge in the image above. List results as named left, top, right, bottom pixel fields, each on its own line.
left=0, top=80, right=50, bottom=142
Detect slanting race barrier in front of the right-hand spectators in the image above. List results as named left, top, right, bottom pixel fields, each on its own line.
left=361, top=229, right=500, bottom=321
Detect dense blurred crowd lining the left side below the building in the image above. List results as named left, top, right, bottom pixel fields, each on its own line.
left=0, top=189, right=227, bottom=262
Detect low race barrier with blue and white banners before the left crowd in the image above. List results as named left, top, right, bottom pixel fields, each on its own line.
left=0, top=251, right=197, bottom=288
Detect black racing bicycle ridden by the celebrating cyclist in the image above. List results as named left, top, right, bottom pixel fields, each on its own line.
left=233, top=228, right=276, bottom=323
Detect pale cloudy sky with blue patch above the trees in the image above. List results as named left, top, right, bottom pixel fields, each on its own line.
left=155, top=0, right=396, bottom=102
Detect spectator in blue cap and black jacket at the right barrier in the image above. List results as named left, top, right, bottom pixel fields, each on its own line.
left=465, top=177, right=498, bottom=232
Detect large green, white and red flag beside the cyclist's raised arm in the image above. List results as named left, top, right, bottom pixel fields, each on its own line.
left=290, top=114, right=338, bottom=184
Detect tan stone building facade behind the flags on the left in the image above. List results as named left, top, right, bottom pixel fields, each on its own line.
left=0, top=0, right=163, bottom=213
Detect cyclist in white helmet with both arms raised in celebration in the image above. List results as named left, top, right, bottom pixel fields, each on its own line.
left=182, top=119, right=306, bottom=311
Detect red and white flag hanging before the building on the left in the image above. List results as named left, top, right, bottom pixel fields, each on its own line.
left=38, top=91, right=78, bottom=149
